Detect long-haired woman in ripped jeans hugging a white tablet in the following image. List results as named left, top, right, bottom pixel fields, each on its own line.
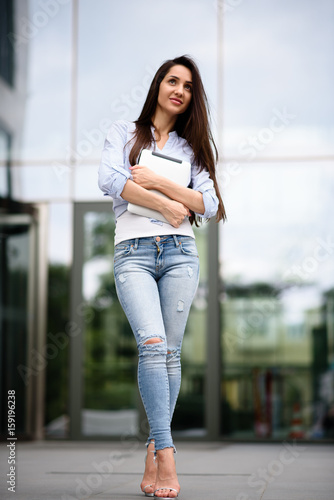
left=99, top=56, right=226, bottom=498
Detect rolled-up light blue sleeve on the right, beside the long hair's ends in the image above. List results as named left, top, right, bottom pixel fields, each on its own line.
left=191, top=166, right=219, bottom=219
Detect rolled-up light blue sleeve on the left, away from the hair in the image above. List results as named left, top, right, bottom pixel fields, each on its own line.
left=98, top=121, right=131, bottom=198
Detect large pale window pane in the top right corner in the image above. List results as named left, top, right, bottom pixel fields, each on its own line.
left=221, top=0, right=334, bottom=159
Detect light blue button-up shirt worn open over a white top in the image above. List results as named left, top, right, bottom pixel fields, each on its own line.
left=99, top=120, right=218, bottom=219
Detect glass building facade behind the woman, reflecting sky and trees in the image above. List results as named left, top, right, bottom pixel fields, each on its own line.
left=0, top=0, right=334, bottom=441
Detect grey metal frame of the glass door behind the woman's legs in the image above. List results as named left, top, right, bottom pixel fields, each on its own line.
left=67, top=200, right=221, bottom=440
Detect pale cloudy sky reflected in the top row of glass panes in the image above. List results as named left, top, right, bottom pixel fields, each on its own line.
left=12, top=0, right=334, bottom=165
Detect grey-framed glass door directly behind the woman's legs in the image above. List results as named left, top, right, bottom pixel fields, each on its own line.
left=68, top=203, right=207, bottom=439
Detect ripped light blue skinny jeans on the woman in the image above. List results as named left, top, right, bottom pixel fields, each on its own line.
left=114, top=235, right=199, bottom=450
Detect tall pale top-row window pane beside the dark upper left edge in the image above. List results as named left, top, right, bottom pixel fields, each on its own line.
left=14, top=0, right=71, bottom=161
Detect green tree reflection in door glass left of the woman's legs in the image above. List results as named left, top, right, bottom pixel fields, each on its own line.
left=84, top=213, right=137, bottom=410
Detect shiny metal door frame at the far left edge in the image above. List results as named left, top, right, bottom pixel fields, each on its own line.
left=0, top=203, right=48, bottom=439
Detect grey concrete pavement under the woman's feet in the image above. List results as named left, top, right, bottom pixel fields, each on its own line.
left=0, top=439, right=334, bottom=500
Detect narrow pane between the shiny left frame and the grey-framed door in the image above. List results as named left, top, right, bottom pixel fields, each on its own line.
left=45, top=203, right=72, bottom=438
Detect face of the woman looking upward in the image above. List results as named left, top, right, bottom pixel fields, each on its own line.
left=157, top=64, right=192, bottom=115
